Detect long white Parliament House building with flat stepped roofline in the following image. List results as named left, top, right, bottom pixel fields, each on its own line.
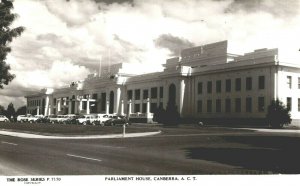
left=26, top=41, right=300, bottom=123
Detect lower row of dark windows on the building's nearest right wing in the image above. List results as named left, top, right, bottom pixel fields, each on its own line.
left=197, top=97, right=265, bottom=113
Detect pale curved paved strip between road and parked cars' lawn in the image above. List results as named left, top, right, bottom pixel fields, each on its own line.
left=0, top=130, right=161, bottom=139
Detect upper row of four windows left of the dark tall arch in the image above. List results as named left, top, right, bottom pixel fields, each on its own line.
left=127, top=87, right=164, bottom=100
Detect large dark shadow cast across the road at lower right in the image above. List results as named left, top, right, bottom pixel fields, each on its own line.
left=185, top=136, right=300, bottom=174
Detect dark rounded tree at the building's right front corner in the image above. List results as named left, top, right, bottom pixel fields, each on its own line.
left=266, top=99, right=292, bottom=128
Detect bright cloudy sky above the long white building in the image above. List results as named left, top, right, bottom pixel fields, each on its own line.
left=0, top=0, right=300, bottom=108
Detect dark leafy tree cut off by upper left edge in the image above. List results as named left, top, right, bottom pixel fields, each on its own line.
left=0, top=0, right=24, bottom=89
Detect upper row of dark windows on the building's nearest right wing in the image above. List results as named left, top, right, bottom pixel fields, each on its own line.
left=198, top=76, right=265, bottom=94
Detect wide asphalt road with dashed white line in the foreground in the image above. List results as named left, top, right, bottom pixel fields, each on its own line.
left=0, top=127, right=300, bottom=176
